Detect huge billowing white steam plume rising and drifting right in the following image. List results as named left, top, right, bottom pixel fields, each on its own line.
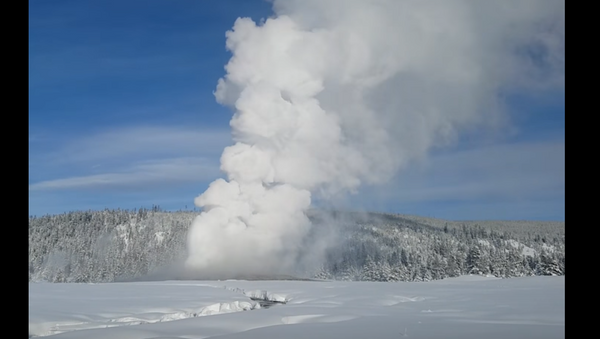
left=186, top=0, right=565, bottom=276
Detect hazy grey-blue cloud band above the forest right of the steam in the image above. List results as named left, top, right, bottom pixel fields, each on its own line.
left=352, top=141, right=565, bottom=206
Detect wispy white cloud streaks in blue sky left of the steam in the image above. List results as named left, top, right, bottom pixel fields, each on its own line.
left=29, top=126, right=231, bottom=191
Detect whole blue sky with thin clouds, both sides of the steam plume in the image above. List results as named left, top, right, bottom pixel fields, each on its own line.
left=29, top=0, right=565, bottom=220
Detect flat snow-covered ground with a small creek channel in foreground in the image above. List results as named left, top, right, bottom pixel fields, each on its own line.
left=29, top=276, right=565, bottom=339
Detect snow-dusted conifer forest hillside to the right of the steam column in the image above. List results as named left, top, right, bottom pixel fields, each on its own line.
left=317, top=214, right=565, bottom=281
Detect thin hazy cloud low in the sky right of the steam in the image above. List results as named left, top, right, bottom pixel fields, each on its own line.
left=351, top=140, right=565, bottom=219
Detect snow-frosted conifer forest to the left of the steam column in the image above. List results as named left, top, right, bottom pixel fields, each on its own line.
left=29, top=207, right=197, bottom=282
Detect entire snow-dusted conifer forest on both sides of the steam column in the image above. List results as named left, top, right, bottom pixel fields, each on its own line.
left=29, top=207, right=565, bottom=282
